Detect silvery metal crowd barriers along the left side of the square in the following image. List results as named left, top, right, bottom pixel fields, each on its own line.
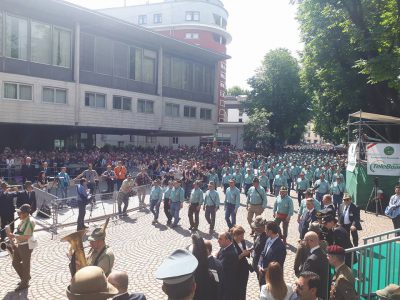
left=35, top=185, right=151, bottom=237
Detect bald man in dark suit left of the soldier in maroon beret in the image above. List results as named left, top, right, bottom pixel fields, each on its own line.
left=302, top=231, right=329, bottom=299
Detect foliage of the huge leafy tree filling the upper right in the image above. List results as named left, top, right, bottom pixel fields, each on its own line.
left=298, top=0, right=400, bottom=143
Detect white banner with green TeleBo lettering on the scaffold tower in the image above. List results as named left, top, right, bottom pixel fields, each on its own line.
left=367, top=143, right=400, bottom=176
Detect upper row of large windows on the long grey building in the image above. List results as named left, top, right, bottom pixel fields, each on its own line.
left=0, top=12, right=214, bottom=95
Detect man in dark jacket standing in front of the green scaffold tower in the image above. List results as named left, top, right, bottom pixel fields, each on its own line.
left=339, top=193, right=362, bottom=247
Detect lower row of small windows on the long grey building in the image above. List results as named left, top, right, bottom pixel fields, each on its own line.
left=4, top=82, right=211, bottom=120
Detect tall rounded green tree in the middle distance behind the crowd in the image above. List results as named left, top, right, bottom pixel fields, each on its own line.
left=245, top=49, right=310, bottom=145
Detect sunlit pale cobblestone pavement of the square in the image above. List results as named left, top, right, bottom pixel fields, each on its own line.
left=0, top=189, right=393, bottom=300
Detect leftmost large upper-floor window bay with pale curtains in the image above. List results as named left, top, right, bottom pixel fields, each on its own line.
left=0, top=12, right=71, bottom=68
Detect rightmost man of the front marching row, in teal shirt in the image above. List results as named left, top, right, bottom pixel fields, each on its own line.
left=273, top=186, right=293, bottom=245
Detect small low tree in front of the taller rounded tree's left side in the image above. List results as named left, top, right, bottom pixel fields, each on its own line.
left=243, top=108, right=272, bottom=151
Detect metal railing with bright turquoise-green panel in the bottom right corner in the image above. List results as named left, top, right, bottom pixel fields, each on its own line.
left=346, top=229, right=400, bottom=300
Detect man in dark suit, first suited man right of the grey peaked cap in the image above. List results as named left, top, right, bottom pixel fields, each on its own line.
left=217, top=232, right=239, bottom=300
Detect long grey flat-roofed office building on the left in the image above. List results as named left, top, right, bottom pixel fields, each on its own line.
left=0, top=0, right=228, bottom=148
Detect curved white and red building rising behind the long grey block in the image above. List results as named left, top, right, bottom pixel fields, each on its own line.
left=101, top=0, right=232, bottom=122
